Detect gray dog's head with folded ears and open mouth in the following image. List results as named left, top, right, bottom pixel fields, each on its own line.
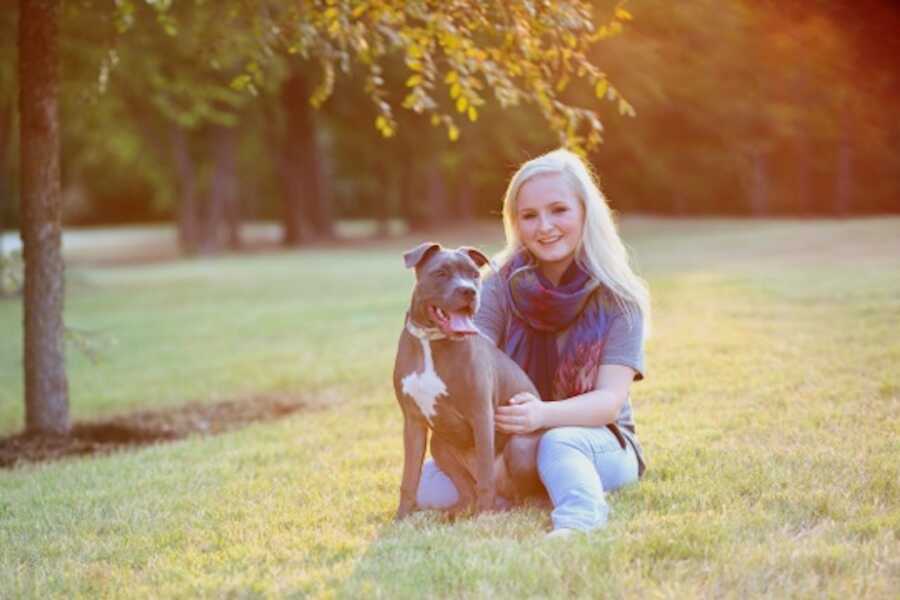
left=403, top=242, right=490, bottom=338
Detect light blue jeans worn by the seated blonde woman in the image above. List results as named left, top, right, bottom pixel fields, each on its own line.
left=416, top=427, right=638, bottom=531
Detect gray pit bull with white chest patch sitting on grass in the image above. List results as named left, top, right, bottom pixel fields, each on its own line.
left=394, top=242, right=538, bottom=519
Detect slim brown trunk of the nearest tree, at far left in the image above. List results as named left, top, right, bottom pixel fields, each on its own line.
left=19, top=0, right=69, bottom=434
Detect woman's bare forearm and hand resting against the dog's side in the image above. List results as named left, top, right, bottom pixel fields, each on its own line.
left=494, top=365, right=636, bottom=434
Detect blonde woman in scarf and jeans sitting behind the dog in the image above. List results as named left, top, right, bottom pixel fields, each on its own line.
left=418, top=150, right=650, bottom=535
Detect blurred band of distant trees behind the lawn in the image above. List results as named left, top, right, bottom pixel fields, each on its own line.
left=0, top=0, right=900, bottom=251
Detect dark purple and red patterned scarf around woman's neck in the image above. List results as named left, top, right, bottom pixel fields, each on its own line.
left=500, top=252, right=607, bottom=400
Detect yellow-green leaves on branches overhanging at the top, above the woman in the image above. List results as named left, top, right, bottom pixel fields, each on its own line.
left=216, top=0, right=634, bottom=148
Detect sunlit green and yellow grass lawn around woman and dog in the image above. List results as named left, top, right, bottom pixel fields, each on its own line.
left=0, top=218, right=900, bottom=598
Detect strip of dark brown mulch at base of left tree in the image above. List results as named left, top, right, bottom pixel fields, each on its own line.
left=0, top=395, right=306, bottom=469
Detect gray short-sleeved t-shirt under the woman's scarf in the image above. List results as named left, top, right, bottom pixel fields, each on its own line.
left=475, top=273, right=644, bottom=472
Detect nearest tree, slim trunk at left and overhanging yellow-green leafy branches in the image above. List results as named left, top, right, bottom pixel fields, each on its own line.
left=19, top=0, right=632, bottom=433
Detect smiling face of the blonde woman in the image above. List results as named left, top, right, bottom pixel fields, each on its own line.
left=516, top=173, right=584, bottom=283
